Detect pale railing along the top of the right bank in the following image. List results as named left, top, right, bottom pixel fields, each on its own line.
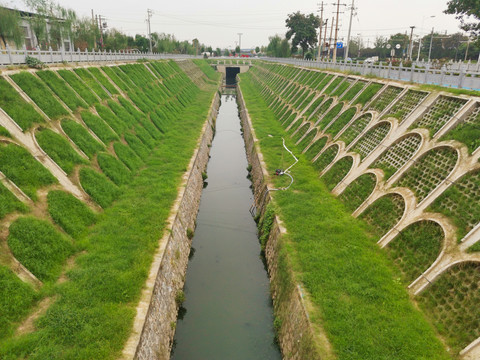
left=262, top=58, right=480, bottom=91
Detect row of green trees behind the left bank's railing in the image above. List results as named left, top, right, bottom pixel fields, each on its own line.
left=0, top=0, right=211, bottom=55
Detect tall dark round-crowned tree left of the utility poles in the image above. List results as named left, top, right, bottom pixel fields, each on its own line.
left=285, top=11, right=320, bottom=56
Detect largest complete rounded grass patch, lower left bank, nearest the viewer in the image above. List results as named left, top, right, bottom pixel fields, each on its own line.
left=8, top=216, right=73, bottom=281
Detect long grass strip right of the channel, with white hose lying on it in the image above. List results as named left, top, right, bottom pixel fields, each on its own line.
left=241, top=73, right=449, bottom=359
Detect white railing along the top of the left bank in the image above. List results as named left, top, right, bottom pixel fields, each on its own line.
left=0, top=47, right=202, bottom=65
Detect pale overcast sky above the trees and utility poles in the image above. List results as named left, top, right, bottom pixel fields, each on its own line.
left=8, top=0, right=460, bottom=49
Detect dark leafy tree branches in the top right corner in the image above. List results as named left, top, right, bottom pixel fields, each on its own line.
left=444, top=0, right=480, bottom=36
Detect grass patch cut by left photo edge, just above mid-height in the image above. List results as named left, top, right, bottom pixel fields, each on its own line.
left=0, top=144, right=57, bottom=200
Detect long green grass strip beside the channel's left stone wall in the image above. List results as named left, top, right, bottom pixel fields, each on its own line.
left=0, top=79, right=215, bottom=360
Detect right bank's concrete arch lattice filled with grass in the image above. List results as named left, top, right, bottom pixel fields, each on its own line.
left=249, top=63, right=480, bottom=359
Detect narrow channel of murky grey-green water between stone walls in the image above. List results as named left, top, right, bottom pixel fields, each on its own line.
left=171, top=95, right=281, bottom=360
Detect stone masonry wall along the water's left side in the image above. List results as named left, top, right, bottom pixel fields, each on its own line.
left=122, top=93, right=220, bottom=360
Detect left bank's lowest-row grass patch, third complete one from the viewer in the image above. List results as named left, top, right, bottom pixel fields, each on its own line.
left=80, top=168, right=120, bottom=209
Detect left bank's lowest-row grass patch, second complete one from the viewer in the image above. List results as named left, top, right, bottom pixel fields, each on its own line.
left=47, top=190, right=97, bottom=239
